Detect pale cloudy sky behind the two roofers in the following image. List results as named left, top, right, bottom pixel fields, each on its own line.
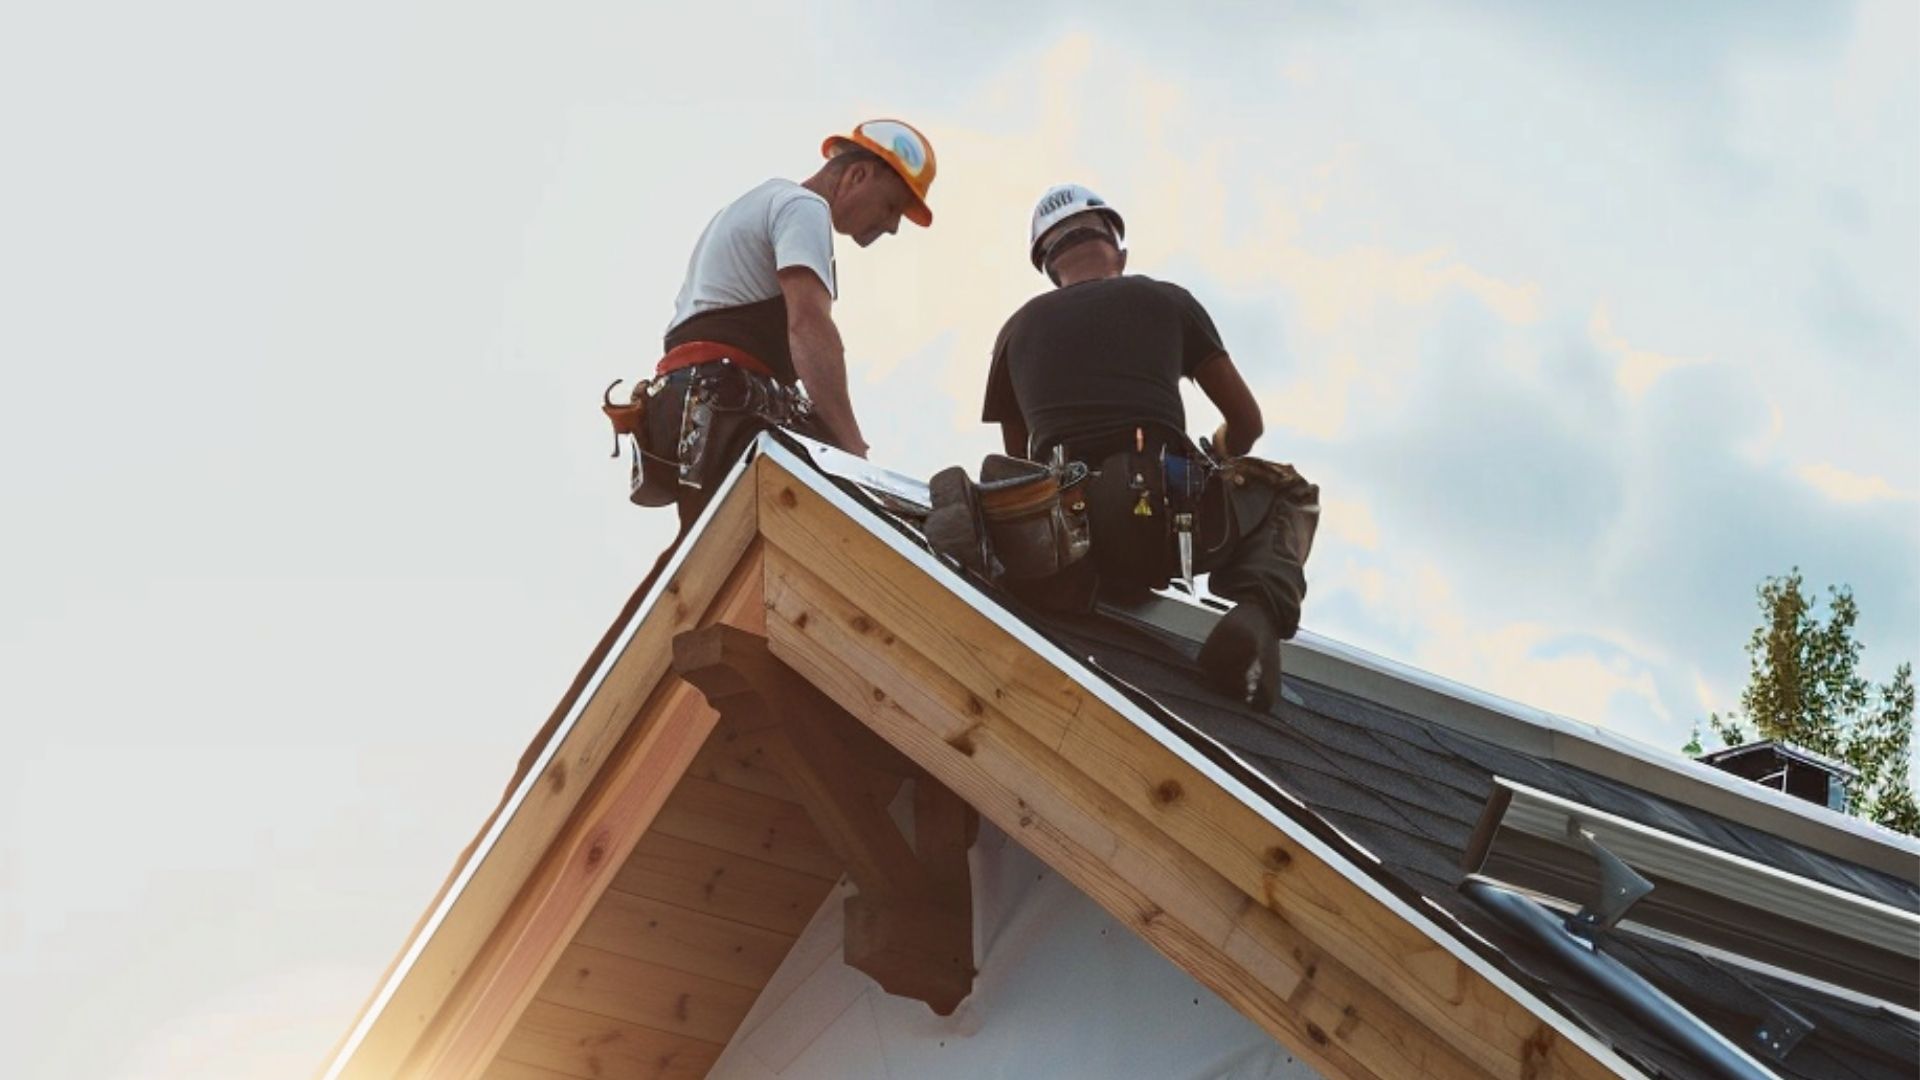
left=0, top=0, right=1920, bottom=1080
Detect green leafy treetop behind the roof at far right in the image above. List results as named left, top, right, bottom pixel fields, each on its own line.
left=1712, top=567, right=1920, bottom=836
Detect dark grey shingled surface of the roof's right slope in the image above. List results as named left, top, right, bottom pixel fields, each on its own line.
left=787, top=440, right=1920, bottom=1080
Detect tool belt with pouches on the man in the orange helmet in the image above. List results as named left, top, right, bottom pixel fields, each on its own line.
left=601, top=342, right=814, bottom=505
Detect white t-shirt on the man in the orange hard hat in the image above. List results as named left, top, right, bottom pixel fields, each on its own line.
left=666, top=181, right=839, bottom=332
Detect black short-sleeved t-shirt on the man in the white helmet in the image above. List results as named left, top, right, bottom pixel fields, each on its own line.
left=981, top=275, right=1227, bottom=454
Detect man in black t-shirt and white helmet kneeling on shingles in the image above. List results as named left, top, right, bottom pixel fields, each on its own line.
left=960, top=184, right=1319, bottom=709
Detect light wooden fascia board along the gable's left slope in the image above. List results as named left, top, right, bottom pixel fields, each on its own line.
left=336, top=475, right=760, bottom=1080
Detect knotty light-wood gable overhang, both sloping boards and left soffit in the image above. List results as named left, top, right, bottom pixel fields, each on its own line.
left=328, top=443, right=1634, bottom=1080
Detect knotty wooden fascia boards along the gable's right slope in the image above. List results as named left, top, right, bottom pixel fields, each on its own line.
left=760, top=453, right=1613, bottom=1076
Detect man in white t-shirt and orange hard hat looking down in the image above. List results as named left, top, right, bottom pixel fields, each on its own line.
left=609, top=119, right=935, bottom=523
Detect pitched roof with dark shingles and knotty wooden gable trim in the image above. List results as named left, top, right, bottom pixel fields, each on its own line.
left=328, top=436, right=1920, bottom=1076
